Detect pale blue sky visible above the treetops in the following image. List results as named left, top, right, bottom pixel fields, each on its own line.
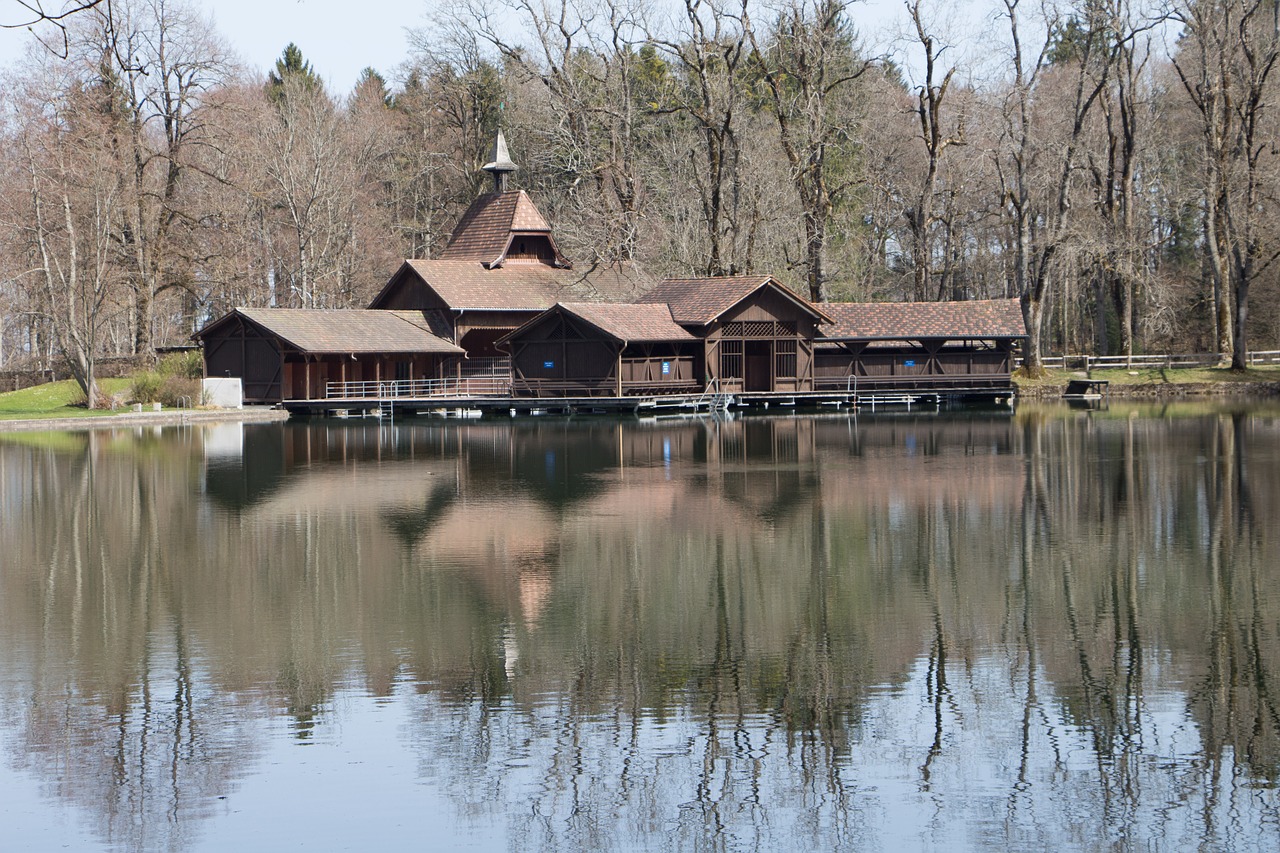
left=0, top=0, right=951, bottom=95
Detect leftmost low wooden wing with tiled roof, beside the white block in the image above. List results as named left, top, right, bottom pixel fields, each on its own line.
left=192, top=307, right=463, bottom=403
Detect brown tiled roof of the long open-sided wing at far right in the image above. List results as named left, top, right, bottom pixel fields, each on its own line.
left=822, top=300, right=1027, bottom=341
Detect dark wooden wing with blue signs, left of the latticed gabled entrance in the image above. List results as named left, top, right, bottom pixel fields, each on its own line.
left=498, top=302, right=701, bottom=397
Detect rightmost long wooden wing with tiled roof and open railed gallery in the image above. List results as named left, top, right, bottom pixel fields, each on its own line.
left=815, top=300, right=1027, bottom=392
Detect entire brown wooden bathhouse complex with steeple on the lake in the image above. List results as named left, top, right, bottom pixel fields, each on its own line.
left=193, top=133, right=1025, bottom=412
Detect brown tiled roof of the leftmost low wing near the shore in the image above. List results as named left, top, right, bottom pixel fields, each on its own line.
left=232, top=309, right=465, bottom=353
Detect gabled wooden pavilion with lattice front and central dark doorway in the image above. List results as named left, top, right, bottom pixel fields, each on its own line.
left=637, top=275, right=829, bottom=393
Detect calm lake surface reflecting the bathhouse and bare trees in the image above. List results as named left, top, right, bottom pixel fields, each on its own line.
left=0, top=406, right=1280, bottom=850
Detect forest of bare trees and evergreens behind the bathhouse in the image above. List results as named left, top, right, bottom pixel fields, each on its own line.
left=0, top=0, right=1280, bottom=405
